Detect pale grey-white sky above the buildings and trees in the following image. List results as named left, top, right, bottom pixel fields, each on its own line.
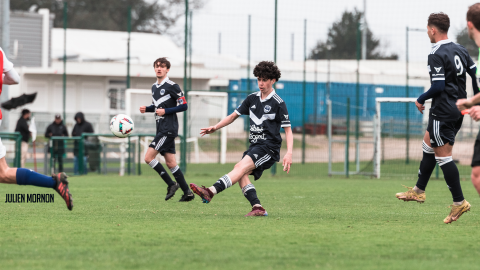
left=183, top=0, right=475, bottom=61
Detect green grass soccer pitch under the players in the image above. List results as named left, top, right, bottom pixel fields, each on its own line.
left=0, top=164, right=480, bottom=269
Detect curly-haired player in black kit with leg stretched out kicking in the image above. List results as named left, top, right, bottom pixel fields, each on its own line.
left=190, top=61, right=293, bottom=216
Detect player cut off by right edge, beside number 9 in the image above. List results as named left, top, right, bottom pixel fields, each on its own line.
left=457, top=3, right=480, bottom=198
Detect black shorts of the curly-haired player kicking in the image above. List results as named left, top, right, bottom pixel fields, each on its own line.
left=242, top=145, right=280, bottom=181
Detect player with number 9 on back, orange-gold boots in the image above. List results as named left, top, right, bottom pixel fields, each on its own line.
left=396, top=13, right=478, bottom=224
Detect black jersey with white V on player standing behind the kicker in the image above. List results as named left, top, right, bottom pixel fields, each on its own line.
left=152, top=77, right=187, bottom=137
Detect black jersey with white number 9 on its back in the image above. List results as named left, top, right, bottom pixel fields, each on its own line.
left=428, top=39, right=476, bottom=121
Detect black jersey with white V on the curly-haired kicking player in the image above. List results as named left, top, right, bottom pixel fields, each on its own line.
left=235, top=89, right=291, bottom=152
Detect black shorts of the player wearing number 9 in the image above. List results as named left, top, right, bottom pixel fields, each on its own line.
left=427, top=116, right=463, bottom=147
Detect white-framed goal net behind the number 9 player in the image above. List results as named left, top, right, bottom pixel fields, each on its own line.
left=374, top=97, right=478, bottom=178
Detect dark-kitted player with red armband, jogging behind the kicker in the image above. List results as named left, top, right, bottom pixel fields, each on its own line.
left=140, top=57, right=195, bottom=202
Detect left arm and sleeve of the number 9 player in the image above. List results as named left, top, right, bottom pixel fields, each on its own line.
left=415, top=54, right=445, bottom=114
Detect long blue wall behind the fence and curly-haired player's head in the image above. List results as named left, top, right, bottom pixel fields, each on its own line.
left=228, top=79, right=423, bottom=127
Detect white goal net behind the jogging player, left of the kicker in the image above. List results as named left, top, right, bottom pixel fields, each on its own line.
left=125, top=89, right=228, bottom=164
